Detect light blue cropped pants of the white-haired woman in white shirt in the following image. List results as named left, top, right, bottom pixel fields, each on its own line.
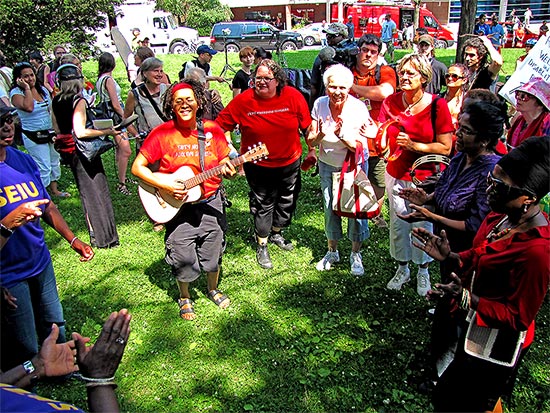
left=319, top=162, right=370, bottom=242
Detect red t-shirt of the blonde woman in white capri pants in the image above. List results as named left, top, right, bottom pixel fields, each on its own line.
left=378, top=92, right=454, bottom=181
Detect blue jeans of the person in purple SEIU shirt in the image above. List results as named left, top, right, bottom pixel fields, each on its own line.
left=2, top=261, right=65, bottom=371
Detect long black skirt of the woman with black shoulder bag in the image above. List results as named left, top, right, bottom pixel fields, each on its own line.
left=71, top=154, right=118, bottom=248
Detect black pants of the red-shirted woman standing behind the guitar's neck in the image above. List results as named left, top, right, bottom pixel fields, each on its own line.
left=244, top=159, right=302, bottom=238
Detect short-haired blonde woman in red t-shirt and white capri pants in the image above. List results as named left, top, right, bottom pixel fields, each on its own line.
left=379, top=54, right=454, bottom=296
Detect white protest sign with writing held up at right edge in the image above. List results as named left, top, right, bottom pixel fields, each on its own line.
left=498, top=36, right=550, bottom=106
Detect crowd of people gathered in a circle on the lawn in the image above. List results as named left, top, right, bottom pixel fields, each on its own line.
left=0, top=17, right=550, bottom=411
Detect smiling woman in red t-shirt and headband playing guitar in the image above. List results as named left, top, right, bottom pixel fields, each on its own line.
left=132, top=79, right=239, bottom=320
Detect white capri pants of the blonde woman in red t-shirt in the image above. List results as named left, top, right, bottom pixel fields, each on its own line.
left=385, top=172, right=433, bottom=265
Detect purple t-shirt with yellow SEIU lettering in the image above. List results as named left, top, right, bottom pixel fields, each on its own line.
left=0, top=147, right=51, bottom=289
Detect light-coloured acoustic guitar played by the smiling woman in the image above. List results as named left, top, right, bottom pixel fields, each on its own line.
left=138, top=143, right=269, bottom=224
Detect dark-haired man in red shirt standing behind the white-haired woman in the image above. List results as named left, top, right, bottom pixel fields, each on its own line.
left=350, top=34, right=397, bottom=228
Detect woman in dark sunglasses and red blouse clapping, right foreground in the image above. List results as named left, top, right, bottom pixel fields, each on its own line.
left=414, top=136, right=550, bottom=412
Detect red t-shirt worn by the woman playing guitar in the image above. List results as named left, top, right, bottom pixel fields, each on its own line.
left=140, top=120, right=229, bottom=199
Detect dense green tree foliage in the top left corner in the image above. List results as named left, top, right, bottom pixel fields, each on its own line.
left=0, top=0, right=122, bottom=62
